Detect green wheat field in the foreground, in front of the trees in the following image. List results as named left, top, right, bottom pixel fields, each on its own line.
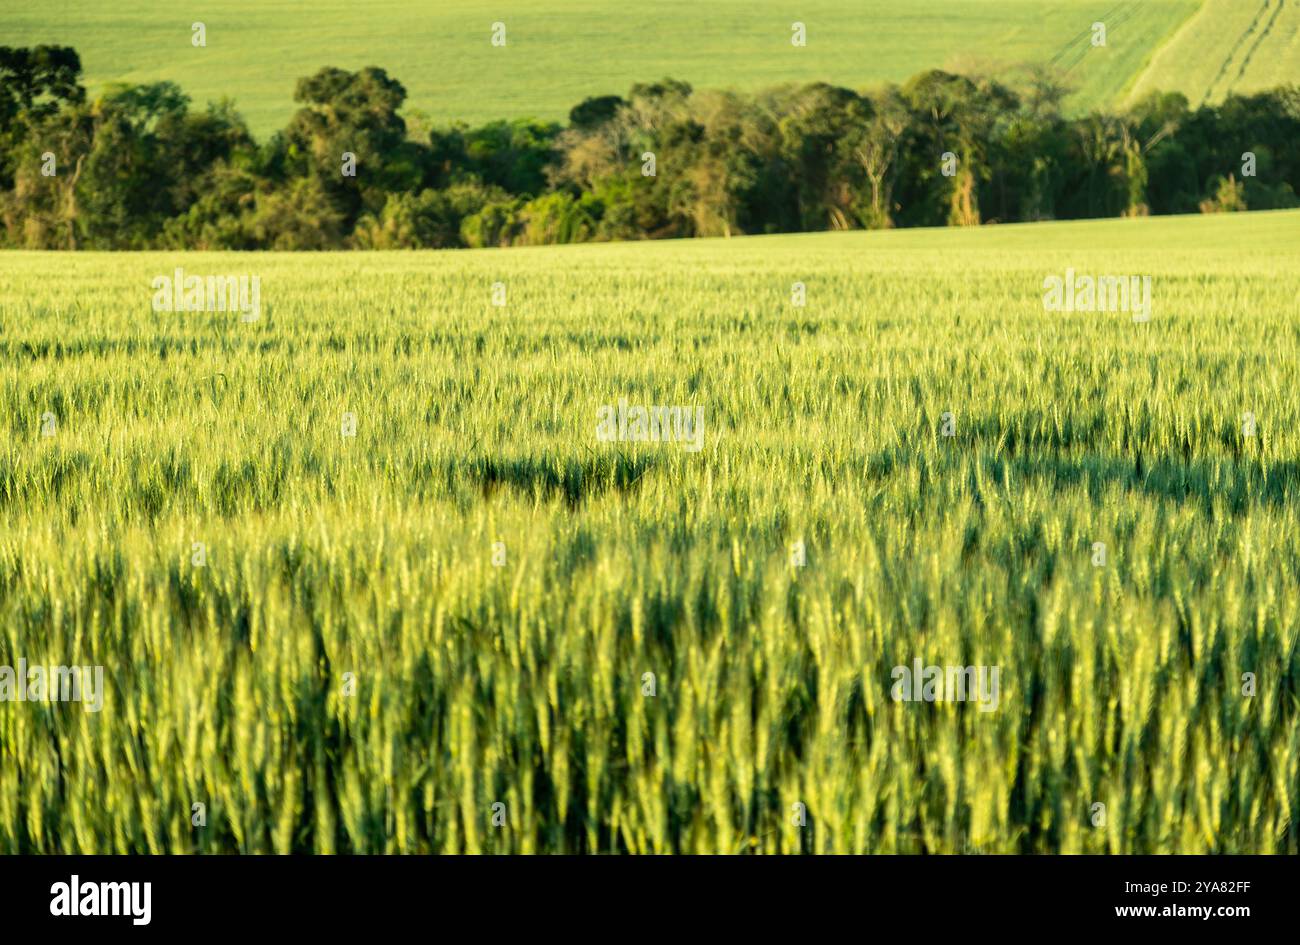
left=0, top=213, right=1300, bottom=854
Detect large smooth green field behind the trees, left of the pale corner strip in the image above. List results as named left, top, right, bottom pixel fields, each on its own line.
left=0, top=0, right=1199, bottom=134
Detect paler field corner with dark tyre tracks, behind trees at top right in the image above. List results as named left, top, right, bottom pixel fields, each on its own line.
left=1134, top=0, right=1300, bottom=105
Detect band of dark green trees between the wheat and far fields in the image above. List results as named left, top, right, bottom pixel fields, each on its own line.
left=0, top=45, right=1300, bottom=250
